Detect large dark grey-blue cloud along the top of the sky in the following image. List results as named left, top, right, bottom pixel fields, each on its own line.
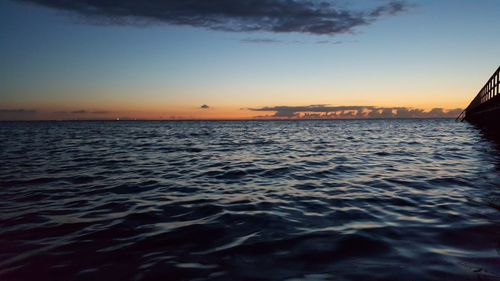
left=14, top=0, right=410, bottom=35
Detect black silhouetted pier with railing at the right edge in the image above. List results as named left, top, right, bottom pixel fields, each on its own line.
left=457, top=67, right=500, bottom=128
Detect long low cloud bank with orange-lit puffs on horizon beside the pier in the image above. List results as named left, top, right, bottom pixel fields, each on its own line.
left=248, top=104, right=462, bottom=119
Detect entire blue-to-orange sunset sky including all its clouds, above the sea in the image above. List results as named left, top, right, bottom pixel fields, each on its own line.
left=0, top=0, right=500, bottom=120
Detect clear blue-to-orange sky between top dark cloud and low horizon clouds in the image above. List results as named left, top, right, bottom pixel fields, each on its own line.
left=0, top=0, right=500, bottom=118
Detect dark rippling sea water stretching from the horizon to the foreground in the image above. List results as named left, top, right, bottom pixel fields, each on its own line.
left=0, top=120, right=500, bottom=281
